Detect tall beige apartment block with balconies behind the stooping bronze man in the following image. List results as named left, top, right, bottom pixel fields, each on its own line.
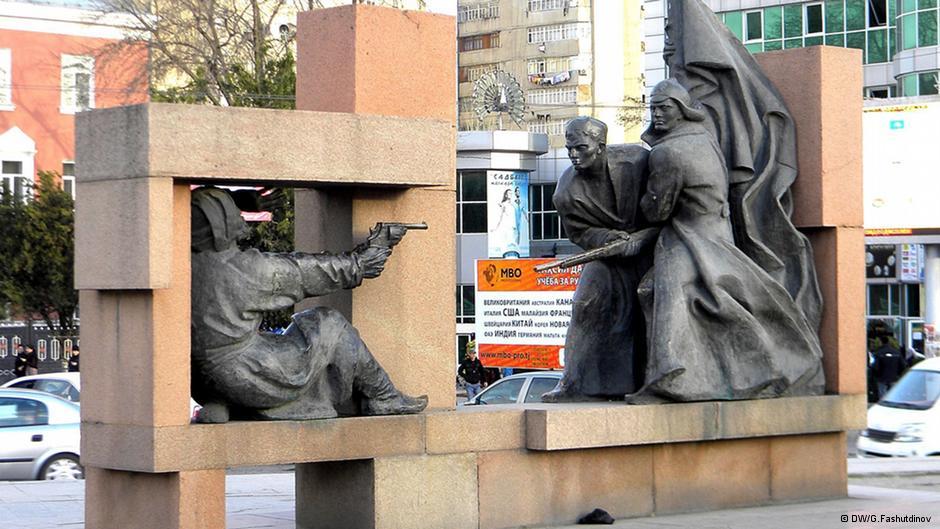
left=457, top=0, right=644, bottom=147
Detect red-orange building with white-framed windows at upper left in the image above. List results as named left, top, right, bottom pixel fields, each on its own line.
left=0, top=0, right=148, bottom=197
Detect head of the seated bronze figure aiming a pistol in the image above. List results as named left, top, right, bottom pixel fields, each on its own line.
left=191, top=187, right=248, bottom=252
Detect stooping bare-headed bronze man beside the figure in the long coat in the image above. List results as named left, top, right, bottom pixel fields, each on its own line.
left=542, top=117, right=655, bottom=402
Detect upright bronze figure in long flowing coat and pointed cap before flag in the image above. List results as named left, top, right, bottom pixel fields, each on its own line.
left=628, top=79, right=823, bottom=402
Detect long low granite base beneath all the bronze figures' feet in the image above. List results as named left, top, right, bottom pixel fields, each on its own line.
left=84, top=395, right=866, bottom=529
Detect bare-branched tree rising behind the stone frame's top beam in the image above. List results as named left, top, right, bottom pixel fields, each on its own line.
left=103, top=0, right=426, bottom=106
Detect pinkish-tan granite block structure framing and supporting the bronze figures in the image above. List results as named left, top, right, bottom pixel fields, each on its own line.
left=76, top=5, right=866, bottom=529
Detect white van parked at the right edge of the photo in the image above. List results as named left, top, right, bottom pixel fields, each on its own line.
left=857, top=358, right=940, bottom=457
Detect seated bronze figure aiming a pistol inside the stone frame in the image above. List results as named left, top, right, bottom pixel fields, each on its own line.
left=192, top=188, right=427, bottom=422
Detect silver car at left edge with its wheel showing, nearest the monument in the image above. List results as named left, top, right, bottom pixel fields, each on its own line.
left=0, top=389, right=85, bottom=480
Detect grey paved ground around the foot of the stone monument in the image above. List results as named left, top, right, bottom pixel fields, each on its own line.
left=0, top=458, right=940, bottom=529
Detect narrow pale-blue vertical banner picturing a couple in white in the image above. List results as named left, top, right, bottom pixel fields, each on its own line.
left=486, top=171, right=529, bottom=258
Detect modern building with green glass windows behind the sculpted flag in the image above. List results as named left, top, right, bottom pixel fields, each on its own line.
left=644, top=0, right=940, bottom=98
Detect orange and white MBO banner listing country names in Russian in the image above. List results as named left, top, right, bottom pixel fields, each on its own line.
left=476, top=259, right=582, bottom=369
